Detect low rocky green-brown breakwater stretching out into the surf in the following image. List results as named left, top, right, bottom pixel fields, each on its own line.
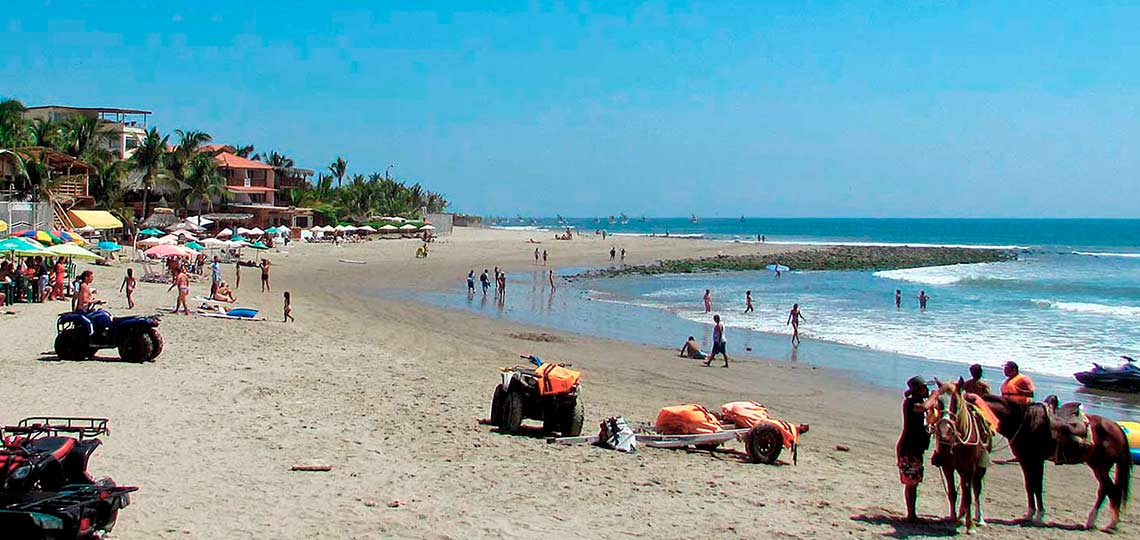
left=579, top=246, right=1017, bottom=277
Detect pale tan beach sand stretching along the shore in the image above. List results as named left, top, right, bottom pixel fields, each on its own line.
left=0, top=229, right=1137, bottom=539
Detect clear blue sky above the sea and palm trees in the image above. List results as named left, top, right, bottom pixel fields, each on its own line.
left=0, top=0, right=1140, bottom=218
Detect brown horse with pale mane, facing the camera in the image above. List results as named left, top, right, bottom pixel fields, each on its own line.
left=926, top=378, right=993, bottom=534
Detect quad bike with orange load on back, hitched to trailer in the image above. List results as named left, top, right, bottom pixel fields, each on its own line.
left=490, top=355, right=585, bottom=436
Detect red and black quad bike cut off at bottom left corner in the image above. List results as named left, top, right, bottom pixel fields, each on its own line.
left=0, top=418, right=138, bottom=540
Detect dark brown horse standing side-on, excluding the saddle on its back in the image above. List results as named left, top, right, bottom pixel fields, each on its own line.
left=985, top=395, right=1132, bottom=530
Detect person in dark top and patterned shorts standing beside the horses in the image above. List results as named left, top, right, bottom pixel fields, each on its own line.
left=895, top=376, right=930, bottom=523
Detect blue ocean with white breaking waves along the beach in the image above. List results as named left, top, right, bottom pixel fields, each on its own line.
left=412, top=218, right=1140, bottom=414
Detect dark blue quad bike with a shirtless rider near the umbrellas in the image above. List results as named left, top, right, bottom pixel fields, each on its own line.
left=56, top=302, right=163, bottom=362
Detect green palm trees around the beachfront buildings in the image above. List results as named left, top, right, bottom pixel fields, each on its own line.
left=0, top=99, right=448, bottom=223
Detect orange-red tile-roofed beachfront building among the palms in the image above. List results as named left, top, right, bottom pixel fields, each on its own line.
left=200, top=145, right=312, bottom=229
